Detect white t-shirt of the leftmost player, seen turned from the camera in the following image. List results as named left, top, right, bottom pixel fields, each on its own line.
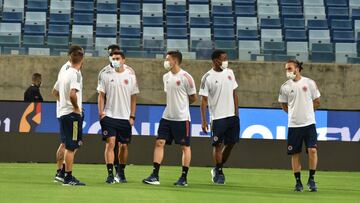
left=58, top=66, right=82, bottom=117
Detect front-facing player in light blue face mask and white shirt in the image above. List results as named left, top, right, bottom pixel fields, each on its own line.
left=97, top=51, right=139, bottom=184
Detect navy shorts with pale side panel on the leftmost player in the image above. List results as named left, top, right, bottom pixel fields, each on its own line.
left=60, top=113, right=83, bottom=151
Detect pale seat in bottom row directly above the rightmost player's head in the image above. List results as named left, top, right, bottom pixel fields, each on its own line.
left=286, top=42, right=309, bottom=62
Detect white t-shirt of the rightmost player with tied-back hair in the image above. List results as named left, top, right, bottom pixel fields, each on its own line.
left=279, top=76, right=320, bottom=127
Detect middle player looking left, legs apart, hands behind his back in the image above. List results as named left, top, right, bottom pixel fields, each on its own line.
left=143, top=51, right=196, bottom=186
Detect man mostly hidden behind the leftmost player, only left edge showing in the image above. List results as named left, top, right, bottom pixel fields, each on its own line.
left=52, top=46, right=82, bottom=183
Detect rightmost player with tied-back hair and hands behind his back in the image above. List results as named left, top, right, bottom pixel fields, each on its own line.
left=279, top=60, right=320, bottom=192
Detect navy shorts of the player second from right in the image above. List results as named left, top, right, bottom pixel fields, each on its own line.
left=211, top=116, right=240, bottom=146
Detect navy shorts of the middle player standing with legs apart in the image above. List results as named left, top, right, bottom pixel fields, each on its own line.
left=156, top=118, right=190, bottom=146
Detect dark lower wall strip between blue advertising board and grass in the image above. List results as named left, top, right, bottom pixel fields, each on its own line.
left=0, top=133, right=360, bottom=173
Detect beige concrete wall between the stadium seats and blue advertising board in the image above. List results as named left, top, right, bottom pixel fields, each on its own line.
left=0, top=56, right=360, bottom=110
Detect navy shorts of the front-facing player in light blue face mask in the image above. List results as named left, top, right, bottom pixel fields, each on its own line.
left=100, top=116, right=132, bottom=144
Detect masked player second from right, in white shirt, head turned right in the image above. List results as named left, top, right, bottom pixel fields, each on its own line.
left=199, top=50, right=240, bottom=184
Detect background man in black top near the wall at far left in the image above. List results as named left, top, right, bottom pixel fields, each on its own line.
left=24, top=73, right=43, bottom=102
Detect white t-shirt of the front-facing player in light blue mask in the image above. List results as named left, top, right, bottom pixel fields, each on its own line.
left=97, top=68, right=139, bottom=120
